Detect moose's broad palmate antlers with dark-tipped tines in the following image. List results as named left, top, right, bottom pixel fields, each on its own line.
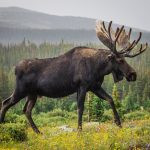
left=96, top=21, right=148, bottom=57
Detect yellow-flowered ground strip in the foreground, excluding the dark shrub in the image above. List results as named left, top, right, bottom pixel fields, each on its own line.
left=0, top=119, right=150, bottom=150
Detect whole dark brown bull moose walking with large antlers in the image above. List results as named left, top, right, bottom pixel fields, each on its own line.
left=0, top=21, right=148, bottom=133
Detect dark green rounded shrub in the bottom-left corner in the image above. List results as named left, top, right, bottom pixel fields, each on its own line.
left=0, top=123, right=27, bottom=142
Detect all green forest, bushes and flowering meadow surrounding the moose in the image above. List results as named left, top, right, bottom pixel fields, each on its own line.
left=0, top=40, right=150, bottom=150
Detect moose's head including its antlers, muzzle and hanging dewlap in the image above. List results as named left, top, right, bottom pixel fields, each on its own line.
left=96, top=21, right=148, bottom=82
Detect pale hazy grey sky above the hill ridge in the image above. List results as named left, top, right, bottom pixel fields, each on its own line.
left=0, top=0, right=150, bottom=31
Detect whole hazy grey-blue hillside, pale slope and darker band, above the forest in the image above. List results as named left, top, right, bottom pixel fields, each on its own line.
left=0, top=7, right=150, bottom=44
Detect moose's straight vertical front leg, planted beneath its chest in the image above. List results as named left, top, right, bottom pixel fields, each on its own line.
left=77, top=87, right=86, bottom=130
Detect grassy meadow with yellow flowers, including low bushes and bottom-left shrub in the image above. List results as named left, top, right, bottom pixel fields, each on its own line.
left=0, top=111, right=150, bottom=150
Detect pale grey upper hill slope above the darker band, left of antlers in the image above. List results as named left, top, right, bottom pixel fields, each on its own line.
left=0, top=7, right=95, bottom=29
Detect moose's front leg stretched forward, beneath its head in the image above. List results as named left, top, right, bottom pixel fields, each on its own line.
left=92, top=87, right=121, bottom=127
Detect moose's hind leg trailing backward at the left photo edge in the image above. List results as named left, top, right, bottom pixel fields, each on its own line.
left=0, top=92, right=25, bottom=123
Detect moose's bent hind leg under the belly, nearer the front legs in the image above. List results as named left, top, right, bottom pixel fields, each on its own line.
left=23, top=96, right=40, bottom=133
